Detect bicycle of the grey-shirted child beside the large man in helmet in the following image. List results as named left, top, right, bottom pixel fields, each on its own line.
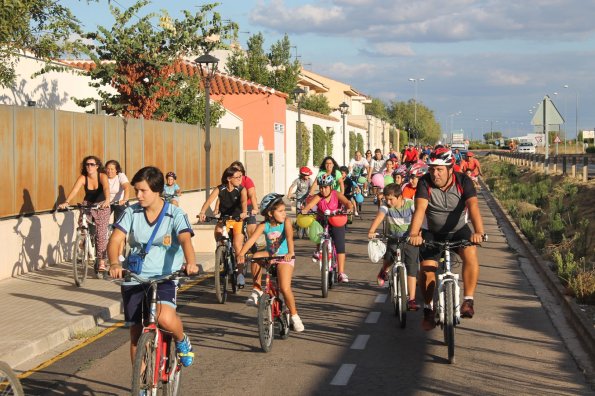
left=377, top=234, right=409, bottom=329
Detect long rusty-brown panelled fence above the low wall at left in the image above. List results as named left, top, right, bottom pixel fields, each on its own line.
left=0, top=105, right=240, bottom=218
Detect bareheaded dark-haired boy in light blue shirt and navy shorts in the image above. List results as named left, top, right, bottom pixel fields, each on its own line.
left=107, top=166, right=198, bottom=367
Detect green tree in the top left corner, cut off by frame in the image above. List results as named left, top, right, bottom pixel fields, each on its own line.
left=0, top=0, right=81, bottom=87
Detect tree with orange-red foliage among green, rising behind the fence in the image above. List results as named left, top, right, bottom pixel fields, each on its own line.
left=77, top=0, right=237, bottom=124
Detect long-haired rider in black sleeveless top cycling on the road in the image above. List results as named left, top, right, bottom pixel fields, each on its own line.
left=198, top=166, right=248, bottom=288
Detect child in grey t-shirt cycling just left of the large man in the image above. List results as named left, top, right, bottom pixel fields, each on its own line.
left=368, top=183, right=419, bottom=311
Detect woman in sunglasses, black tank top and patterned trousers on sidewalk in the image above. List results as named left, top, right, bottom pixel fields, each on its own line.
left=58, top=155, right=110, bottom=271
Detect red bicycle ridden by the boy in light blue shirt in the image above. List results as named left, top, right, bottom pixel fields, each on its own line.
left=116, top=271, right=188, bottom=396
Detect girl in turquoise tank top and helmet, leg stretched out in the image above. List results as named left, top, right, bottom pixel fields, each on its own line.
left=237, top=193, right=304, bottom=332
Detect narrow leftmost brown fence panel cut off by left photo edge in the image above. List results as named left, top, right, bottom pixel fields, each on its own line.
left=0, top=106, right=16, bottom=216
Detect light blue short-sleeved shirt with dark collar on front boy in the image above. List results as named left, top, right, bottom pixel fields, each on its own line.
left=115, top=203, right=194, bottom=278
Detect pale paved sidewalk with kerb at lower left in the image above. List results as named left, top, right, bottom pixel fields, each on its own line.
left=0, top=253, right=215, bottom=367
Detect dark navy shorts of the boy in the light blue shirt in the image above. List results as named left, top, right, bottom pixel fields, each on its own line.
left=121, top=281, right=178, bottom=326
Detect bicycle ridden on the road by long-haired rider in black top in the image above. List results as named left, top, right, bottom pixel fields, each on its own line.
left=201, top=216, right=246, bottom=304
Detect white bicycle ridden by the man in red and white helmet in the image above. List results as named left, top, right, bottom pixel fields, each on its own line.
left=424, top=240, right=474, bottom=364
